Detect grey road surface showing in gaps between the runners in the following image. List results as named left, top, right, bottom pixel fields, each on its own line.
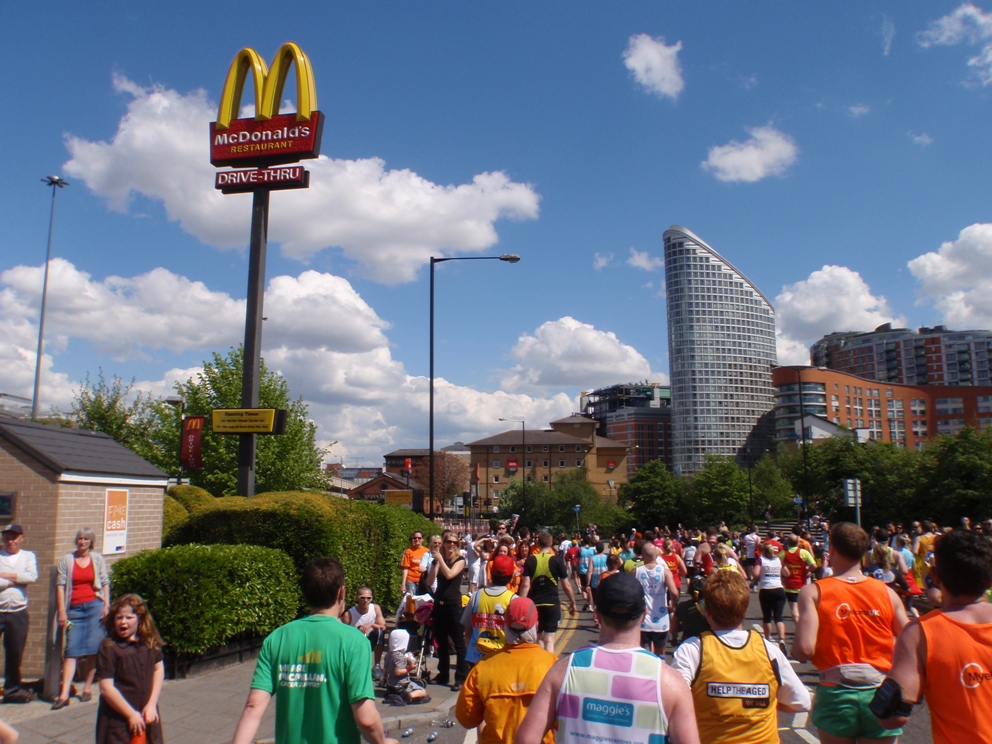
left=422, top=594, right=932, bottom=744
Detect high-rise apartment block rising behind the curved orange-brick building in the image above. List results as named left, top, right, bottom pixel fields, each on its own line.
left=809, top=323, right=992, bottom=385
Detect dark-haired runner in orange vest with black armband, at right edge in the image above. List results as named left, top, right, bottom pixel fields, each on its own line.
left=872, top=530, right=992, bottom=744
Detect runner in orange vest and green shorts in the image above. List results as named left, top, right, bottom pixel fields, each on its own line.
left=792, top=522, right=908, bottom=744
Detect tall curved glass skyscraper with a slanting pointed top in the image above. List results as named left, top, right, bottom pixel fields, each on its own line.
left=665, top=225, right=778, bottom=473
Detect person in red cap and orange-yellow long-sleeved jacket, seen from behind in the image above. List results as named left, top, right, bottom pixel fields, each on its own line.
left=455, top=597, right=556, bottom=744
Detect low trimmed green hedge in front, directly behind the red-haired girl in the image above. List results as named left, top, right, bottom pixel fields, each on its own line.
left=111, top=545, right=300, bottom=655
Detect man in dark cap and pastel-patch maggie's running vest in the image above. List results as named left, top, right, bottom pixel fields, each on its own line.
left=514, top=573, right=699, bottom=744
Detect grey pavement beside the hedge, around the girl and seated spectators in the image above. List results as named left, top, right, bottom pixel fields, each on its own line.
left=0, top=644, right=458, bottom=744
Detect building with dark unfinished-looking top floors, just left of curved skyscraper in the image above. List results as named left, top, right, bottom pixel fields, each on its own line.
left=580, top=382, right=672, bottom=478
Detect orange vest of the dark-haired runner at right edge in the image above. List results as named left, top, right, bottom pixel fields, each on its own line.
left=920, top=610, right=992, bottom=744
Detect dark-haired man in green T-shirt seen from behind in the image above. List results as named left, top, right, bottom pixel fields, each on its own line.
left=233, top=558, right=396, bottom=744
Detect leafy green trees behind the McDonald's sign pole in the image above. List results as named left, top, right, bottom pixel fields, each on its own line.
left=73, top=347, right=327, bottom=496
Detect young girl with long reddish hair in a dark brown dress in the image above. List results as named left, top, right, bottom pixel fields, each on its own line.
left=96, top=594, right=165, bottom=744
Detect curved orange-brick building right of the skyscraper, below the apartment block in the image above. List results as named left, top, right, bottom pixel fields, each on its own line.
left=772, top=366, right=992, bottom=449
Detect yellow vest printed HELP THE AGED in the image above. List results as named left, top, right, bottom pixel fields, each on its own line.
left=691, top=630, right=781, bottom=744
